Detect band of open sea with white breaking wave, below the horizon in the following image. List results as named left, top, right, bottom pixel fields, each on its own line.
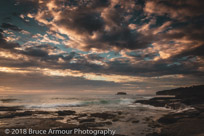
left=1, top=95, right=176, bottom=110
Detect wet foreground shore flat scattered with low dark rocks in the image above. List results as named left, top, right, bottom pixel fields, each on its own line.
left=0, top=104, right=167, bottom=136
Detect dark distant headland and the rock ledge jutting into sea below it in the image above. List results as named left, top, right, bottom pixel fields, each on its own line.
left=136, top=85, right=204, bottom=109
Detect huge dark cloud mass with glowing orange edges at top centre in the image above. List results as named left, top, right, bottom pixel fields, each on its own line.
left=43, top=1, right=151, bottom=50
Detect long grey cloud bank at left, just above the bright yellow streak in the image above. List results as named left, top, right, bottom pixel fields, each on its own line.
left=0, top=34, right=102, bottom=73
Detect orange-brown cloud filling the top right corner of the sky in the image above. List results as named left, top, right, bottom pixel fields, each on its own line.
left=144, top=0, right=204, bottom=20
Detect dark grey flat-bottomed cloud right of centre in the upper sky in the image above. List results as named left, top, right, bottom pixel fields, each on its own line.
left=85, top=27, right=151, bottom=50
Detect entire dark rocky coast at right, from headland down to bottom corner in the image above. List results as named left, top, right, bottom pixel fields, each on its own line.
left=135, top=85, right=204, bottom=136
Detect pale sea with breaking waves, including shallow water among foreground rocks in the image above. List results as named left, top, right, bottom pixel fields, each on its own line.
left=0, top=94, right=171, bottom=136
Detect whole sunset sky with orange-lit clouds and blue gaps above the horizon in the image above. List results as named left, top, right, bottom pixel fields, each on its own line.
left=0, top=0, right=204, bottom=94
